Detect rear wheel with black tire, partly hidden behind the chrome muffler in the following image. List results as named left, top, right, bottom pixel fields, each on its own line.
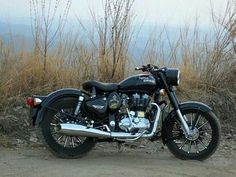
left=41, top=97, right=95, bottom=158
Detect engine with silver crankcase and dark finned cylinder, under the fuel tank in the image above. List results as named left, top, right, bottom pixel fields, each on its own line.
left=119, top=93, right=151, bottom=133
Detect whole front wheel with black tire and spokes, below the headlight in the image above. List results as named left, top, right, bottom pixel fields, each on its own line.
left=167, top=109, right=220, bottom=160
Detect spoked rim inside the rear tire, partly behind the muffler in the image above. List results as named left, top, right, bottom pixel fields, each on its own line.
left=50, top=108, right=86, bottom=148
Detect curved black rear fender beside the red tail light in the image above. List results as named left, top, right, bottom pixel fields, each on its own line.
left=33, top=88, right=89, bottom=125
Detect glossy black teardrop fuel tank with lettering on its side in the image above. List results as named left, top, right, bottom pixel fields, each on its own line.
left=119, top=74, right=156, bottom=92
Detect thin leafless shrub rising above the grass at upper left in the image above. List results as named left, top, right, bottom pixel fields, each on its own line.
left=30, top=0, right=71, bottom=71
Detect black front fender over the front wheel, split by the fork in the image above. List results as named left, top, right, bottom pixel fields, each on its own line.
left=162, top=101, right=212, bottom=144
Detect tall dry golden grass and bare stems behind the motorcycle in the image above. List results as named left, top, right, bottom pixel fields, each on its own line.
left=0, top=0, right=236, bottom=129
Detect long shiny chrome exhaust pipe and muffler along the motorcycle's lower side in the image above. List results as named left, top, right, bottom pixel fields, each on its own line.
left=57, top=103, right=161, bottom=139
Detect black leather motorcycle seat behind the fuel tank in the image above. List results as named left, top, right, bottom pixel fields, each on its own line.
left=83, top=80, right=118, bottom=92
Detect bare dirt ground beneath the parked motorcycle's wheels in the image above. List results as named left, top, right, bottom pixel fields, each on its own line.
left=0, top=106, right=236, bottom=177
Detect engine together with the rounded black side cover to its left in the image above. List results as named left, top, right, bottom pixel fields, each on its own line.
left=85, top=92, right=152, bottom=133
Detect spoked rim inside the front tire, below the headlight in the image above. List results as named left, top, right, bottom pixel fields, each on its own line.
left=171, top=113, right=213, bottom=154
